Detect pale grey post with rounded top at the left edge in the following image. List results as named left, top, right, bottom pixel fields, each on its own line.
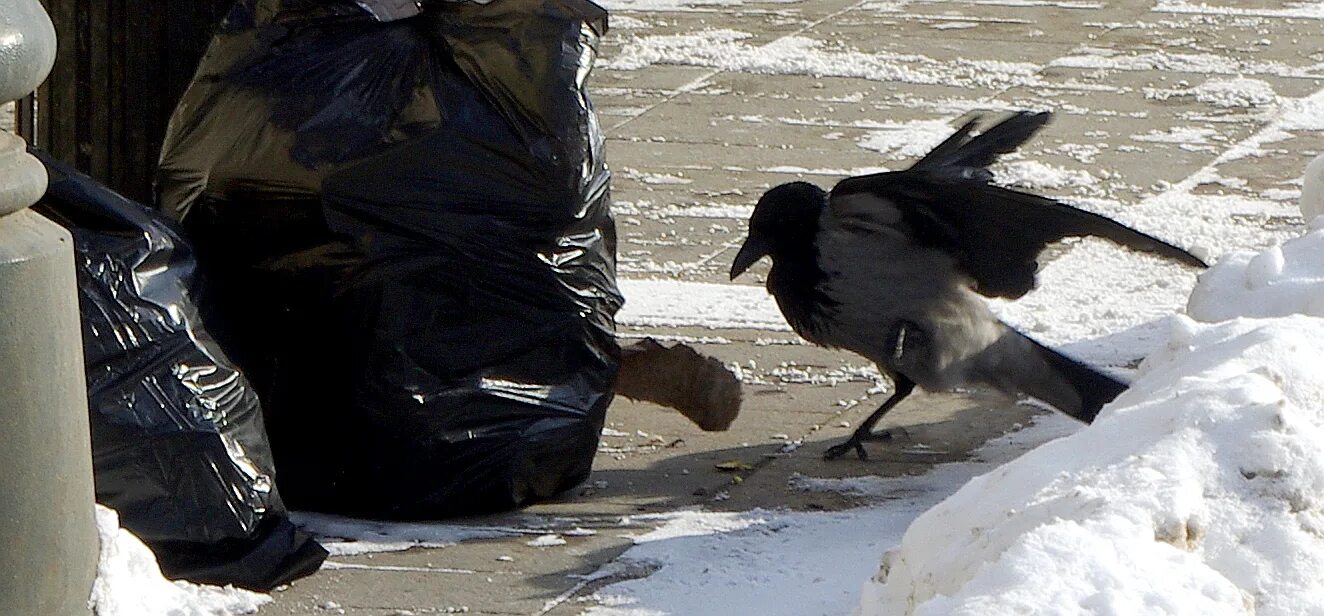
left=0, top=0, right=99, bottom=616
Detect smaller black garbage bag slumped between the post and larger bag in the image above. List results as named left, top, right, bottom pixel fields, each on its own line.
left=33, top=151, right=327, bottom=591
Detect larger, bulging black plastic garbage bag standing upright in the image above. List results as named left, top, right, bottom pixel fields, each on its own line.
left=158, top=0, right=621, bottom=518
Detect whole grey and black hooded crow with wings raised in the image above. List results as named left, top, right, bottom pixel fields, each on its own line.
left=731, top=113, right=1205, bottom=460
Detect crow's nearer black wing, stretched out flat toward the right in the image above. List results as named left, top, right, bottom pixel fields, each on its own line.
left=829, top=172, right=1205, bottom=298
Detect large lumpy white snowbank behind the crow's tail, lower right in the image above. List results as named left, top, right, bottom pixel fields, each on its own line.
left=857, top=224, right=1324, bottom=616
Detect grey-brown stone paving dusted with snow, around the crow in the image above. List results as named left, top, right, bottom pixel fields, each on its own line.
left=10, top=0, right=1324, bottom=616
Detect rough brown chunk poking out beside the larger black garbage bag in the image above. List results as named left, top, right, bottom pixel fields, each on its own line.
left=614, top=338, right=740, bottom=432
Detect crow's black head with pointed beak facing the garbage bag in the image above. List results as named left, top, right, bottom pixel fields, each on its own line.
left=731, top=181, right=828, bottom=280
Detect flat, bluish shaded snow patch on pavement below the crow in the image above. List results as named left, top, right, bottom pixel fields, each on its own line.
left=585, top=415, right=1079, bottom=616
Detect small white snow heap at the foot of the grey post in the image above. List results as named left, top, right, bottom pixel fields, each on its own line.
left=89, top=505, right=271, bottom=616
